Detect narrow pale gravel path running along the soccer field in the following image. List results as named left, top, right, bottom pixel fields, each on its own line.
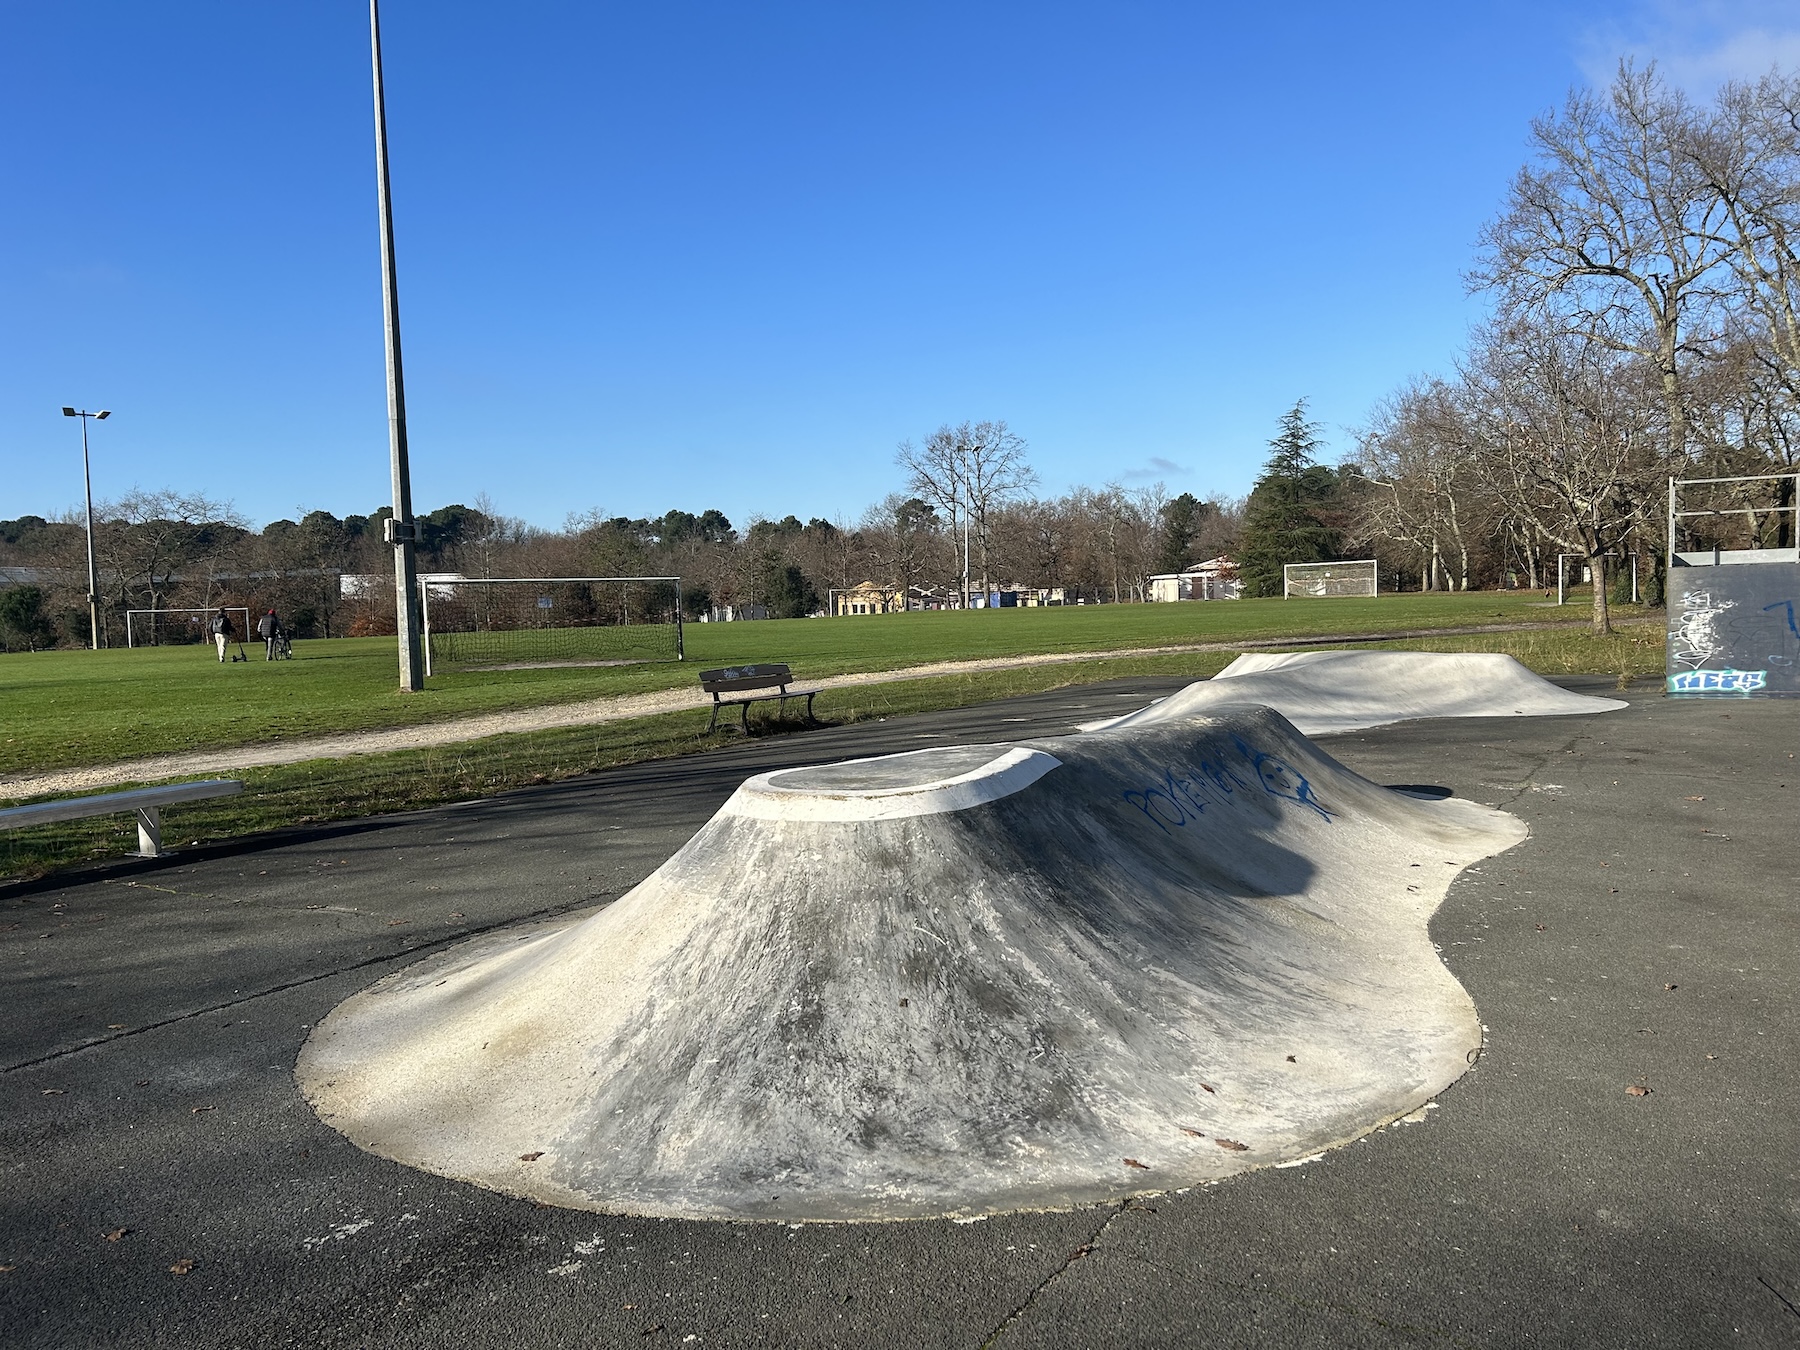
left=0, top=623, right=1634, bottom=797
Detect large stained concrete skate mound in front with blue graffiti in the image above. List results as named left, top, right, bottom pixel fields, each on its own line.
left=299, top=707, right=1525, bottom=1220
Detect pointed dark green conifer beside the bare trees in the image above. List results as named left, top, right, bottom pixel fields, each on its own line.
left=1237, top=400, right=1337, bottom=596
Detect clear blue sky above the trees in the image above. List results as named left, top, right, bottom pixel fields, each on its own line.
left=0, top=0, right=1800, bottom=526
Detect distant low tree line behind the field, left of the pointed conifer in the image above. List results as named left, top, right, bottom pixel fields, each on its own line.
left=0, top=455, right=1242, bottom=650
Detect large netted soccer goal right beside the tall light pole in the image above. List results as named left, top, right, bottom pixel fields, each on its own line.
left=419, top=576, right=682, bottom=675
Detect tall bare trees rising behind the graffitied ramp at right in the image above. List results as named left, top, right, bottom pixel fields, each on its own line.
left=1339, top=63, right=1800, bottom=632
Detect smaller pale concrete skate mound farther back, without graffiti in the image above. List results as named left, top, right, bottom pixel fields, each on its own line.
left=1082, top=652, right=1627, bottom=736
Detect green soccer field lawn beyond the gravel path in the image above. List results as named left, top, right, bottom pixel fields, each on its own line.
left=0, top=592, right=1648, bottom=772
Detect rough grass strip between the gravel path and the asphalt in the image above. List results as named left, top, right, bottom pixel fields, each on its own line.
left=0, top=626, right=1663, bottom=880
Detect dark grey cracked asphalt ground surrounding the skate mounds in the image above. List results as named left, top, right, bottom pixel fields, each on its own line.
left=0, top=679, right=1800, bottom=1350
